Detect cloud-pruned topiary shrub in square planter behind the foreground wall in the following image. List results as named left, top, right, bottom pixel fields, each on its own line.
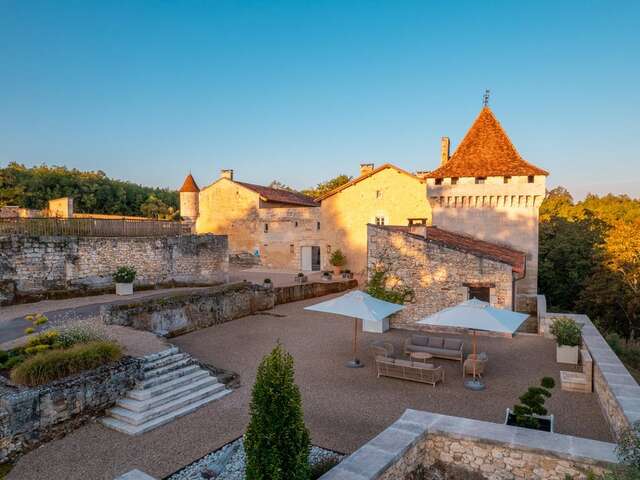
left=504, top=377, right=556, bottom=432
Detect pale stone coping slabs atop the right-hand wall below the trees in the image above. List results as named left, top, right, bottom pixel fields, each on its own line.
left=546, top=313, right=640, bottom=424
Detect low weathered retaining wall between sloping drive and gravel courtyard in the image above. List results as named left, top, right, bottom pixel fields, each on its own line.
left=100, top=282, right=275, bottom=337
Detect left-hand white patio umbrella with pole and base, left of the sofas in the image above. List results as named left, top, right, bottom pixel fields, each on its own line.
left=304, top=290, right=404, bottom=368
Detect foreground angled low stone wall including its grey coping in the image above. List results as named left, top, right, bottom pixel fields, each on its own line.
left=320, top=409, right=617, bottom=480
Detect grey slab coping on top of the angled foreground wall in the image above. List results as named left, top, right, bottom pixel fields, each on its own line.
left=320, top=409, right=618, bottom=480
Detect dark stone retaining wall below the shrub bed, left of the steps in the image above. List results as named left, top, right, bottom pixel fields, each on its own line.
left=0, top=357, right=142, bottom=463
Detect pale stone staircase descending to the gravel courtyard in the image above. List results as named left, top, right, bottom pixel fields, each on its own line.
left=100, top=347, right=231, bottom=435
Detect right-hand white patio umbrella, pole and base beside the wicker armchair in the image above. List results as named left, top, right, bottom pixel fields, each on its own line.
left=417, top=298, right=529, bottom=390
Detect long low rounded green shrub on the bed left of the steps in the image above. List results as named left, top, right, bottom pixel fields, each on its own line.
left=11, top=342, right=122, bottom=385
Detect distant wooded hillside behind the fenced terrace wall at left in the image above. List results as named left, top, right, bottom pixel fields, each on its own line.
left=0, top=162, right=179, bottom=219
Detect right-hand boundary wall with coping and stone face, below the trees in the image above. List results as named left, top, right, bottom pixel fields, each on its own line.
left=540, top=313, right=640, bottom=437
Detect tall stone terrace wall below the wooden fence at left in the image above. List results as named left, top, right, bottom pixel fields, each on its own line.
left=0, top=235, right=228, bottom=303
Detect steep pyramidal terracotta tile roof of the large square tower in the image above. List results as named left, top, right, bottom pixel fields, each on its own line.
left=427, top=107, right=549, bottom=178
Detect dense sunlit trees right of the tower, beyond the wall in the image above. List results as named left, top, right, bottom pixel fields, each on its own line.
left=538, top=187, right=640, bottom=339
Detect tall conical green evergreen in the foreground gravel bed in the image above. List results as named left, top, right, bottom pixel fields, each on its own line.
left=244, top=343, right=311, bottom=480
